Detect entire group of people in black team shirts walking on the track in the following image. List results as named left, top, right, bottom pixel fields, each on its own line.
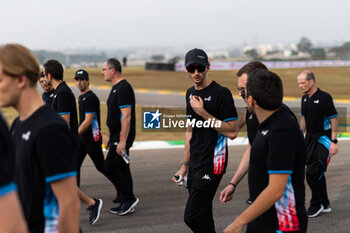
left=0, top=44, right=338, bottom=233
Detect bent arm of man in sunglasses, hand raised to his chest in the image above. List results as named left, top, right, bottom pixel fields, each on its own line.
left=190, top=96, right=239, bottom=139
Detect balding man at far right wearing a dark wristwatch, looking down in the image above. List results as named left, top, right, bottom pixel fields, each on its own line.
left=298, top=70, right=338, bottom=217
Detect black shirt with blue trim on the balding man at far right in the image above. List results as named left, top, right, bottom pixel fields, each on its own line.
left=301, top=88, right=338, bottom=138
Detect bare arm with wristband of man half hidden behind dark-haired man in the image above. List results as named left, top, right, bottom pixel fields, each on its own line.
left=220, top=143, right=251, bottom=204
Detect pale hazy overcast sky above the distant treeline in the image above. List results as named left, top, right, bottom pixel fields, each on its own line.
left=0, top=0, right=350, bottom=50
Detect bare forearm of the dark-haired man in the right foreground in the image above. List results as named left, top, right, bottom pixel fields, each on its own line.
left=224, top=174, right=290, bottom=233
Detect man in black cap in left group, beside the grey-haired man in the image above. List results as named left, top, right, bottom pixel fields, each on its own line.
left=74, top=69, right=105, bottom=182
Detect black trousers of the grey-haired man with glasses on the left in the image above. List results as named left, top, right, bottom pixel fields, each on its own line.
left=105, top=145, right=135, bottom=201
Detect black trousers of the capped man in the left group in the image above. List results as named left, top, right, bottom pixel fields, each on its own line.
left=77, top=141, right=105, bottom=185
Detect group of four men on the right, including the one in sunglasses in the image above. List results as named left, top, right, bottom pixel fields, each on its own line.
left=173, top=49, right=338, bottom=233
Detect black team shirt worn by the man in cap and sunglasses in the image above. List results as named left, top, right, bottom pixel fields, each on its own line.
left=186, top=81, right=238, bottom=174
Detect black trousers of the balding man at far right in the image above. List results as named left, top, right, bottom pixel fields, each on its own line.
left=306, top=140, right=329, bottom=207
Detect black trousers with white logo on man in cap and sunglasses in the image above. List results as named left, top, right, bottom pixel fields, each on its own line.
left=184, top=170, right=223, bottom=233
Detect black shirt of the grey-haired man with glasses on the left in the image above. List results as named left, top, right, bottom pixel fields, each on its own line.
left=107, top=79, right=135, bottom=147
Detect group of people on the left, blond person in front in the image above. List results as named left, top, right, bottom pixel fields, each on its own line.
left=0, top=44, right=139, bottom=233
